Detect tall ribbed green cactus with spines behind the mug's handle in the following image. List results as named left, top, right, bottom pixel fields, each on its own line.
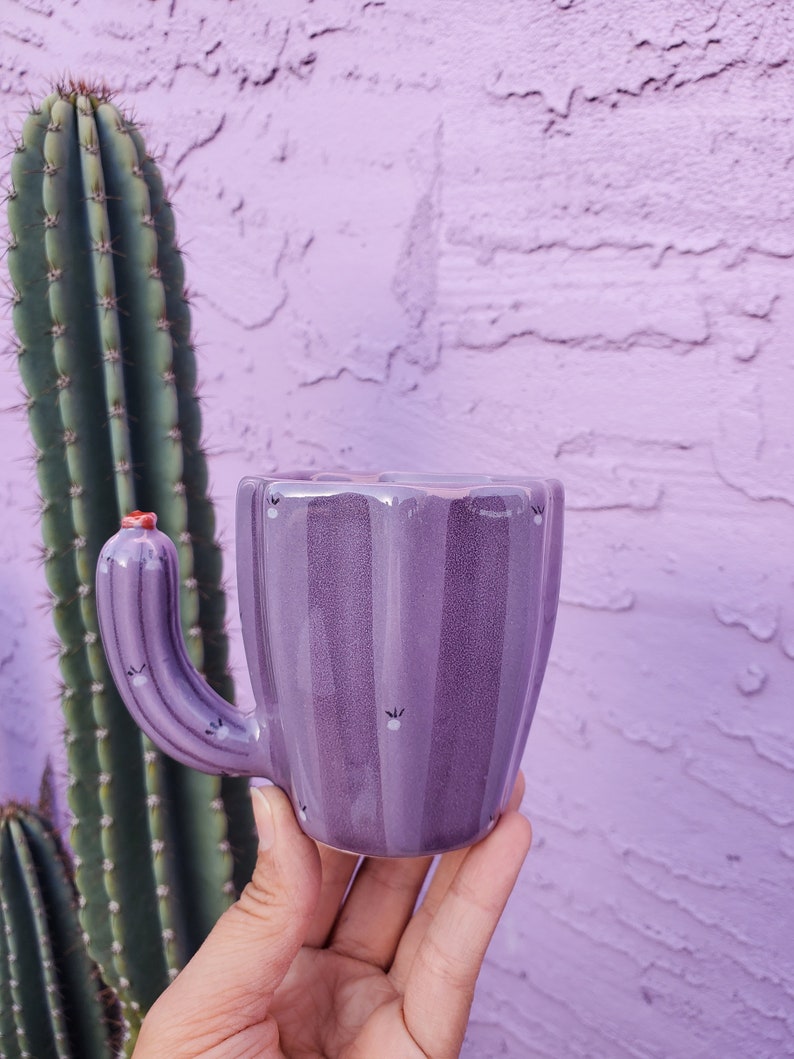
left=8, top=85, right=253, bottom=1041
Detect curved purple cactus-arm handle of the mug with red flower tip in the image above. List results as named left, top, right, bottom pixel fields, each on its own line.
left=96, top=511, right=271, bottom=776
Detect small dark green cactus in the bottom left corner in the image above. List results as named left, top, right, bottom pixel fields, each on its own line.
left=0, top=804, right=121, bottom=1059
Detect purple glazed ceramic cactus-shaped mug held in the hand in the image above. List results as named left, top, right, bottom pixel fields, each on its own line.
left=96, top=472, right=563, bottom=857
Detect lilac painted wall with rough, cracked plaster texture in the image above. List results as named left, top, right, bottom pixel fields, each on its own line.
left=0, top=0, right=794, bottom=1059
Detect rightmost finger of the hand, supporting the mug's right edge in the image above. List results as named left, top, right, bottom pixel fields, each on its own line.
left=403, top=812, right=531, bottom=1055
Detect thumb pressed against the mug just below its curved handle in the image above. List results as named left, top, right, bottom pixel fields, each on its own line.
left=138, top=787, right=322, bottom=1054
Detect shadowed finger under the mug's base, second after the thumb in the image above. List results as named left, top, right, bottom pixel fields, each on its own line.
left=329, top=857, right=433, bottom=970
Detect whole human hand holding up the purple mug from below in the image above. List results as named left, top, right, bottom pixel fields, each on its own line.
left=134, top=775, right=531, bottom=1059
